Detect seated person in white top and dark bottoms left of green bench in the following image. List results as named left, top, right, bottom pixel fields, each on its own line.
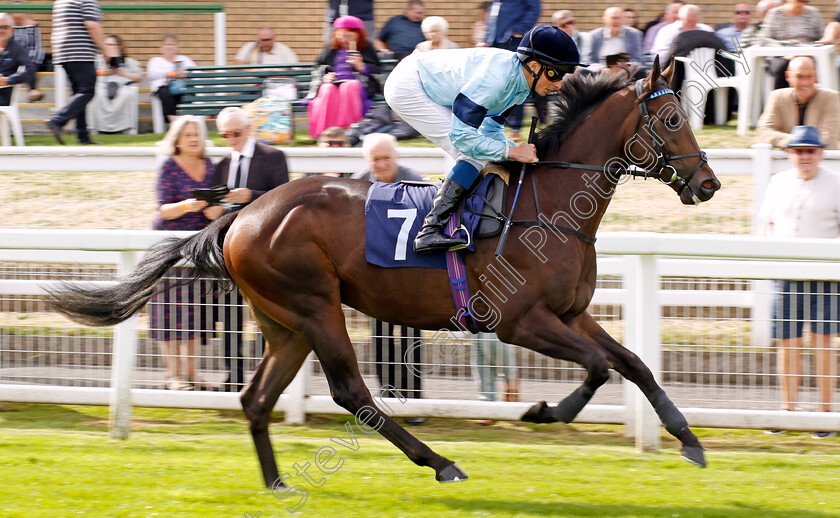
left=146, top=33, right=196, bottom=129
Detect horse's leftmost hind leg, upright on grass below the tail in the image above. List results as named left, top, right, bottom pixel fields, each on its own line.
left=240, top=308, right=312, bottom=488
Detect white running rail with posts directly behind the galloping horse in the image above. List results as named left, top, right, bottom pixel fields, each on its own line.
left=0, top=229, right=840, bottom=456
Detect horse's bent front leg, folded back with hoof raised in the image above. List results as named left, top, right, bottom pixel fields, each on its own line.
left=498, top=307, right=609, bottom=423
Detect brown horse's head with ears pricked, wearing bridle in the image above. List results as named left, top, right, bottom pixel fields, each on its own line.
left=624, top=57, right=720, bottom=205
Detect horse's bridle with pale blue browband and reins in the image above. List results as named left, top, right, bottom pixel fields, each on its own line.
left=537, top=79, right=709, bottom=203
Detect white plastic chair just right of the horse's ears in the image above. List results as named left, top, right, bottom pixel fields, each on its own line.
left=675, top=47, right=750, bottom=130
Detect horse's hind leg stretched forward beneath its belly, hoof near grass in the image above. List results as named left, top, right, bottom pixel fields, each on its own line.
left=303, top=306, right=467, bottom=482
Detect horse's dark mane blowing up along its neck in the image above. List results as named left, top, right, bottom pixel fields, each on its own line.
left=534, top=71, right=633, bottom=159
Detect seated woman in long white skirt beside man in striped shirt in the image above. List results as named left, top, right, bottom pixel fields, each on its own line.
left=88, top=35, right=143, bottom=132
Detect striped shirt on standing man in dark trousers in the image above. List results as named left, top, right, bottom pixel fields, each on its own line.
left=52, top=0, right=102, bottom=63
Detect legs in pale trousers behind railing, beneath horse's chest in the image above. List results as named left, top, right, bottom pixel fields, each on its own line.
left=472, top=333, right=519, bottom=425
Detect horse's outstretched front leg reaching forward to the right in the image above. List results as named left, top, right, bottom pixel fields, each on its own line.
left=581, top=314, right=706, bottom=467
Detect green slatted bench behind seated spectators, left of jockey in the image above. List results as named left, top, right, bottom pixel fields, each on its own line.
left=177, top=59, right=396, bottom=117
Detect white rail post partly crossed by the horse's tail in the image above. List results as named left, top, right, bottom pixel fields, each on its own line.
left=109, top=251, right=140, bottom=439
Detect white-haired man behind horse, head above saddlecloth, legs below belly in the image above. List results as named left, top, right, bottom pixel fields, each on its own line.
left=351, top=133, right=426, bottom=425
